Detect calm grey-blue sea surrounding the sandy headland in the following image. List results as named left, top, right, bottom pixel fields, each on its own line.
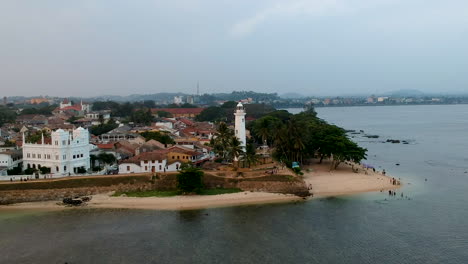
left=0, top=105, right=468, bottom=264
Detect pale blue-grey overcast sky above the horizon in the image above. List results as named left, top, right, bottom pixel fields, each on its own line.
left=0, top=0, right=468, bottom=96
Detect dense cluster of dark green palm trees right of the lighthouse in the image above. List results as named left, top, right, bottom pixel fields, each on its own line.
left=248, top=108, right=367, bottom=169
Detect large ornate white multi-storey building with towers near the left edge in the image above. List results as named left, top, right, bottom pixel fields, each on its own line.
left=23, top=127, right=91, bottom=174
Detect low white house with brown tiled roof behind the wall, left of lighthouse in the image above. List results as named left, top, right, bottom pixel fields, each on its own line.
left=119, top=152, right=182, bottom=174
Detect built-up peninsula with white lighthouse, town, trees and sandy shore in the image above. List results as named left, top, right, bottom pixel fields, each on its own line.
left=0, top=99, right=398, bottom=210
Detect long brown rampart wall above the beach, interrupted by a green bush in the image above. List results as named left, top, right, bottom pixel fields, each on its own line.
left=0, top=173, right=310, bottom=205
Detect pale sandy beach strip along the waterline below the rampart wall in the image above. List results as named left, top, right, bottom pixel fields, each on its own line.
left=0, top=162, right=400, bottom=211
